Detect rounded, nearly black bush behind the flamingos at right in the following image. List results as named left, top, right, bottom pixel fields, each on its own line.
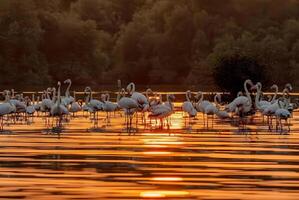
left=213, top=55, right=266, bottom=94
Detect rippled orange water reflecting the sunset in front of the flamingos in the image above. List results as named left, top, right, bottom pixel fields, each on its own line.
left=0, top=106, right=299, bottom=199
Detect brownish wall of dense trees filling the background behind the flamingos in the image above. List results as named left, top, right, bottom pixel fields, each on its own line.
left=0, top=0, right=299, bottom=90
